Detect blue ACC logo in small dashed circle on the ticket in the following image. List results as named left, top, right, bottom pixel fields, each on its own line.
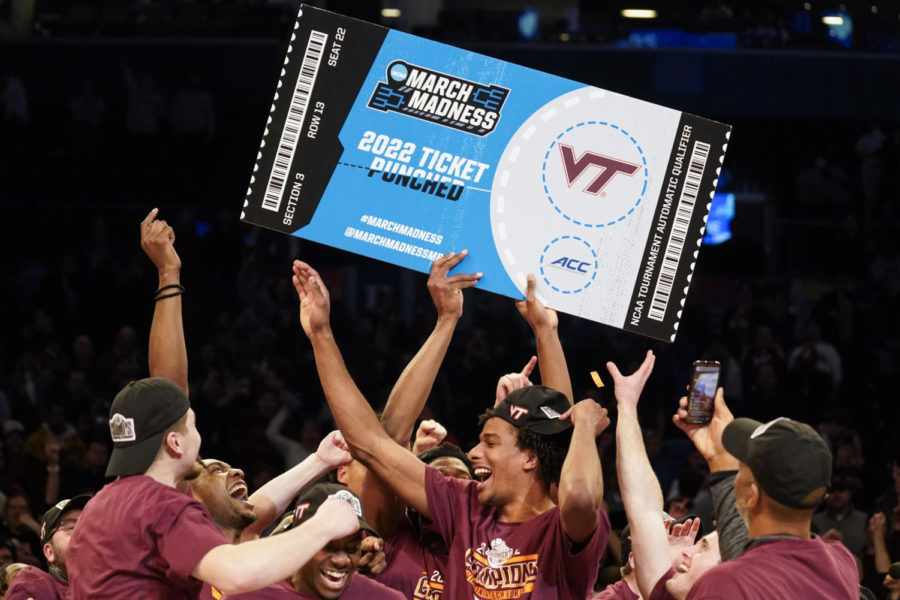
left=540, top=235, right=598, bottom=294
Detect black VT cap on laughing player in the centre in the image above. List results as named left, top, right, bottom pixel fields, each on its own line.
left=490, top=385, right=572, bottom=435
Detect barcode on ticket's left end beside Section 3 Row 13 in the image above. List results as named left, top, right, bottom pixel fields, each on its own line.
left=263, top=31, right=328, bottom=212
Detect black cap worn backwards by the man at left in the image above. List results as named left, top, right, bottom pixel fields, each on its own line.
left=106, top=377, right=191, bottom=477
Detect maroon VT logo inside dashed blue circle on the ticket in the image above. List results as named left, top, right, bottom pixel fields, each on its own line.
left=541, top=121, right=649, bottom=228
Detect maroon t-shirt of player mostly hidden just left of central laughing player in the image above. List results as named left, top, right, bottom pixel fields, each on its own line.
left=375, top=515, right=447, bottom=600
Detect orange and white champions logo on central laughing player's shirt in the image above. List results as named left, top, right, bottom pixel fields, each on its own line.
left=466, top=538, right=538, bottom=600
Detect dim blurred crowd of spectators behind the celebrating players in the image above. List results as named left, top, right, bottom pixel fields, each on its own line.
left=0, top=180, right=900, bottom=592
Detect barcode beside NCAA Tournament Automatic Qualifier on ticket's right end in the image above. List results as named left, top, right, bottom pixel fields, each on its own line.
left=647, top=142, right=709, bottom=321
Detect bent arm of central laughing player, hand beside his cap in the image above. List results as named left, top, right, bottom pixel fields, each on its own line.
left=559, top=398, right=609, bottom=544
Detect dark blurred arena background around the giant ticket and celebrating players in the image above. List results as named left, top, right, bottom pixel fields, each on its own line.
left=0, top=0, right=900, bottom=584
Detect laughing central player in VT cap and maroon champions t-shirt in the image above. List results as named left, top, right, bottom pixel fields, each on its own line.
left=293, top=261, right=646, bottom=600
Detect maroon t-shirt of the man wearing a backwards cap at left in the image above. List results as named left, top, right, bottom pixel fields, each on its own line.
left=66, top=475, right=228, bottom=600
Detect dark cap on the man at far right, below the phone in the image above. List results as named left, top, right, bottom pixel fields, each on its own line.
left=722, top=417, right=831, bottom=509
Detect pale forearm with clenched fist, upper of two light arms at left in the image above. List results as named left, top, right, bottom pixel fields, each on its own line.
left=241, top=431, right=351, bottom=541
